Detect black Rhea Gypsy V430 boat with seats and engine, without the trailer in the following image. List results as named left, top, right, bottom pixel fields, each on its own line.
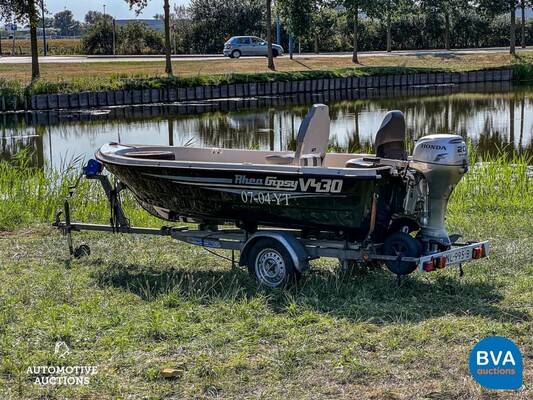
left=96, top=104, right=462, bottom=246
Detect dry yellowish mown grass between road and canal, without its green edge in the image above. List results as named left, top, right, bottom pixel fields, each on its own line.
left=0, top=52, right=533, bottom=87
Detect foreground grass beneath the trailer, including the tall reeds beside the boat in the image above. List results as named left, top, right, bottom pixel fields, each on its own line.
left=0, top=152, right=533, bottom=399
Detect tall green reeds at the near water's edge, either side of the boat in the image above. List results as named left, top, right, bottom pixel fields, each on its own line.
left=0, top=151, right=533, bottom=230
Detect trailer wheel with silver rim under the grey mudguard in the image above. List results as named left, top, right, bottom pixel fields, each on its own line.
left=248, top=238, right=302, bottom=288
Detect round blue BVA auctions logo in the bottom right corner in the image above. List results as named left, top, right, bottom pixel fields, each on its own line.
left=469, top=336, right=523, bottom=390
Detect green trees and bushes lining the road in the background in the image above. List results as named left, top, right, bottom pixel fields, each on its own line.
left=0, top=0, right=533, bottom=79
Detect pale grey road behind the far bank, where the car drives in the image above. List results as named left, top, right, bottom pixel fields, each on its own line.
left=0, top=47, right=531, bottom=64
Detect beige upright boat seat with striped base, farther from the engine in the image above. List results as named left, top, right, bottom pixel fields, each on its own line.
left=265, top=104, right=330, bottom=165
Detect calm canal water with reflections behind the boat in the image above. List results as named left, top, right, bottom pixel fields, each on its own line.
left=0, top=84, right=533, bottom=167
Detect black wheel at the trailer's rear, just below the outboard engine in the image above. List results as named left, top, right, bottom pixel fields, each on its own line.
left=383, top=232, right=422, bottom=275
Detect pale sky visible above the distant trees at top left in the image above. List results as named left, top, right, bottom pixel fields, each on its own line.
left=44, top=0, right=189, bottom=21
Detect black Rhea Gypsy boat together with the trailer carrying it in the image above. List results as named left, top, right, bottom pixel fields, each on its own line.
left=54, top=104, right=489, bottom=287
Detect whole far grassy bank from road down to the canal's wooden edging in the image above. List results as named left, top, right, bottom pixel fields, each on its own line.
left=0, top=52, right=533, bottom=102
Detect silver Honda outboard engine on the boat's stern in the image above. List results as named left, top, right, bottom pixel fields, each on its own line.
left=405, top=134, right=468, bottom=251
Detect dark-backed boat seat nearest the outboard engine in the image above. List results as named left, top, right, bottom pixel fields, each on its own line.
left=375, top=110, right=407, bottom=160
